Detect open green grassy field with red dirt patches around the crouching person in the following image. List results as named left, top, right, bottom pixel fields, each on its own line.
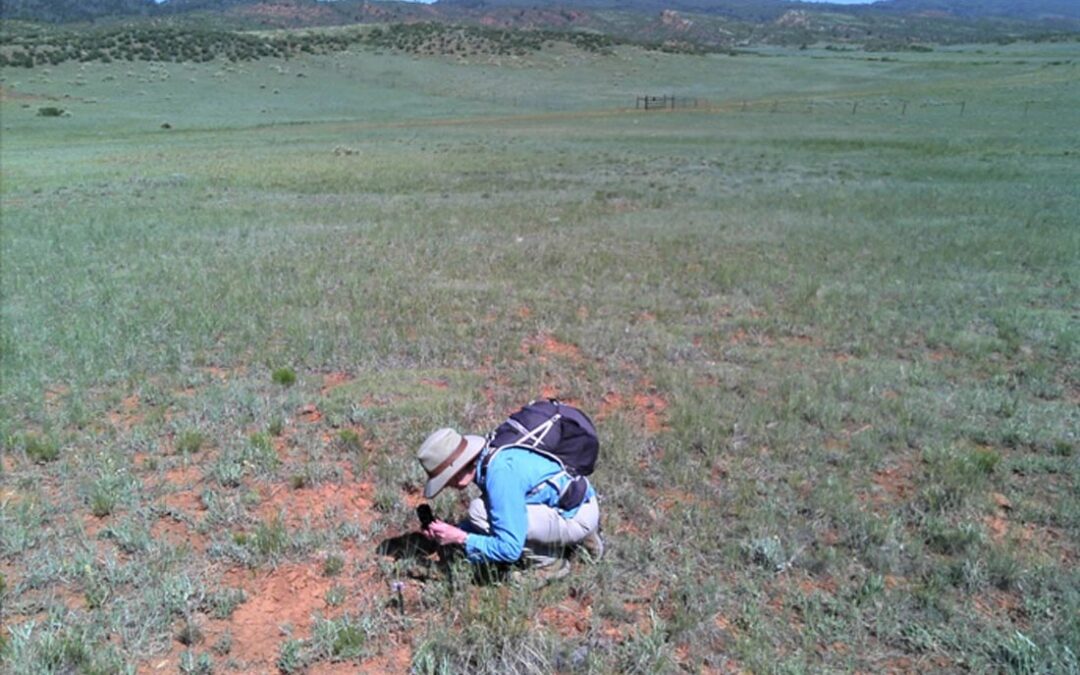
left=0, top=39, right=1080, bottom=673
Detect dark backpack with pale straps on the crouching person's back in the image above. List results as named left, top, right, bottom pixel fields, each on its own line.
left=481, top=399, right=600, bottom=510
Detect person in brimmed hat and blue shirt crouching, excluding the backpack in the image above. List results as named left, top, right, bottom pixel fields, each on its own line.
left=417, top=429, right=604, bottom=576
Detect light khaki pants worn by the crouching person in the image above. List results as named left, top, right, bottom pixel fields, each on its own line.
left=468, top=497, right=600, bottom=565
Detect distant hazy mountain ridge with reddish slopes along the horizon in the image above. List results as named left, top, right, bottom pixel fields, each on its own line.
left=0, top=0, right=1080, bottom=40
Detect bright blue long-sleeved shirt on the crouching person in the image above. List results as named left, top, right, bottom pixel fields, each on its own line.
left=465, top=447, right=595, bottom=563
